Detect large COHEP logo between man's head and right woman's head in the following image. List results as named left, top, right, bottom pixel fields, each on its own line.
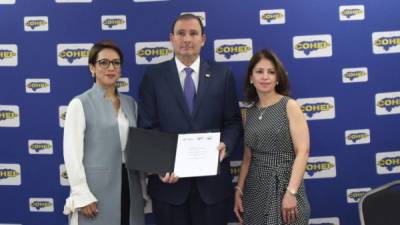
left=214, top=38, right=253, bottom=62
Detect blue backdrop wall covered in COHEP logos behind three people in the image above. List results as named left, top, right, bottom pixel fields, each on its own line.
left=0, top=0, right=400, bottom=225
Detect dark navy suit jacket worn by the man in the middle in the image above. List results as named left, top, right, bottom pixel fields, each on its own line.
left=138, top=59, right=242, bottom=205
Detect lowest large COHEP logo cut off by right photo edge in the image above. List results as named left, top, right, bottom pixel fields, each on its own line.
left=375, top=151, right=400, bottom=174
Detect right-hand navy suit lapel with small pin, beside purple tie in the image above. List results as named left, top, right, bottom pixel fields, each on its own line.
left=192, top=62, right=212, bottom=117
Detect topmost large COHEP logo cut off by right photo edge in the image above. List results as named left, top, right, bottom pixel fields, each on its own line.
left=372, top=31, right=400, bottom=54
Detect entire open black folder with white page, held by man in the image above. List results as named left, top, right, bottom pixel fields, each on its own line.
left=125, top=128, right=220, bottom=178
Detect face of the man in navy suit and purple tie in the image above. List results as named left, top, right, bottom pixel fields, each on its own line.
left=169, top=19, right=206, bottom=61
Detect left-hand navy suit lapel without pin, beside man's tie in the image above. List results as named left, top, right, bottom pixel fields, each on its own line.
left=164, top=59, right=190, bottom=119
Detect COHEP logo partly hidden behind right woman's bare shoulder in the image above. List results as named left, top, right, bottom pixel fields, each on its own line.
left=296, top=97, right=335, bottom=120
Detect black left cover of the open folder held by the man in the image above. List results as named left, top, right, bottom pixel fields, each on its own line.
left=125, top=127, right=178, bottom=176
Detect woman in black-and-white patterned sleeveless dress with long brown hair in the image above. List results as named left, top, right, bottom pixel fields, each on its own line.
left=234, top=50, right=310, bottom=225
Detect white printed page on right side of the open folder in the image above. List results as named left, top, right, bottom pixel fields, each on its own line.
left=174, top=132, right=220, bottom=177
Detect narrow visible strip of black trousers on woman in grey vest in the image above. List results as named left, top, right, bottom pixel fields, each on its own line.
left=121, top=164, right=131, bottom=225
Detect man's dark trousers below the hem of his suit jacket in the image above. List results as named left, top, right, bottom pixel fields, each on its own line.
left=152, top=182, right=233, bottom=225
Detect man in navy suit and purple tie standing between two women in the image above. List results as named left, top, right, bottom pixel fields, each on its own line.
left=138, top=14, right=242, bottom=225
